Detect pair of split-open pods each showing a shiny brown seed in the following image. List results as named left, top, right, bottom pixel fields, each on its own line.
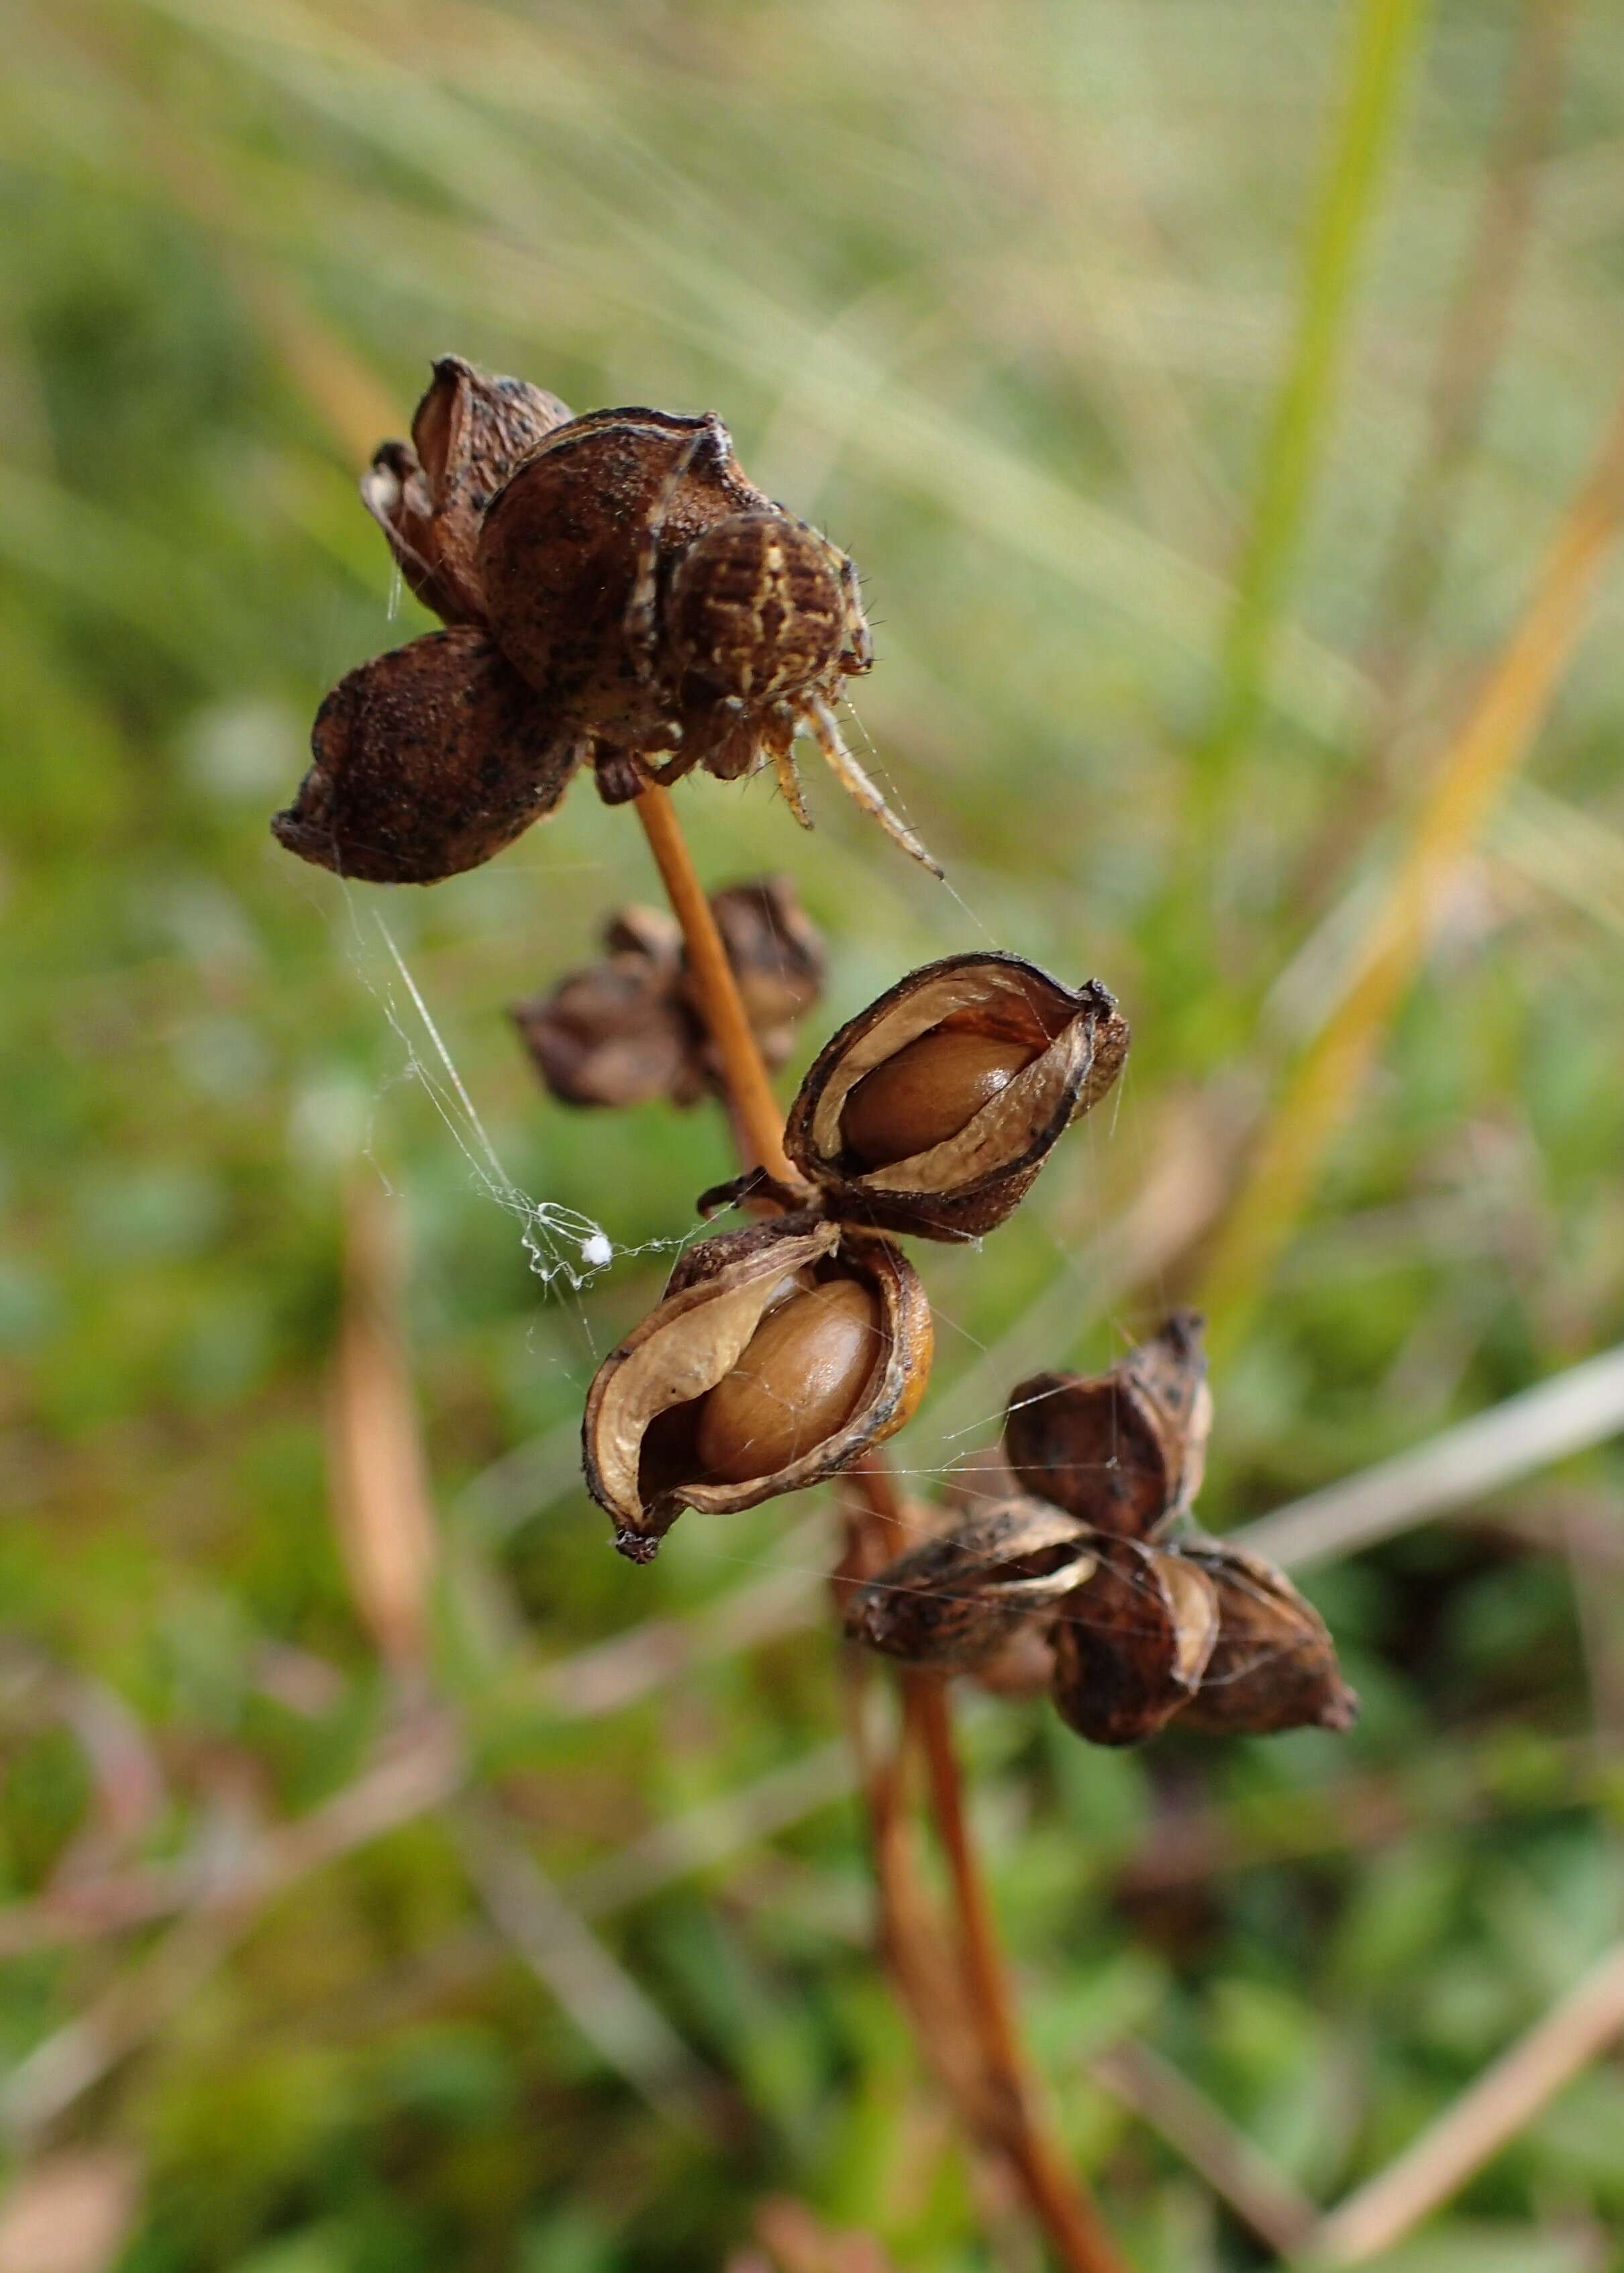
left=582, top=955, right=1128, bottom=1559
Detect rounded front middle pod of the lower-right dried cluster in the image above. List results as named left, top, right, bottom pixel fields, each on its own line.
left=1051, top=1532, right=1219, bottom=1744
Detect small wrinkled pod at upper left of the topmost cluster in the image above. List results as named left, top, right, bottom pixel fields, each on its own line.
left=362, top=354, right=568, bottom=625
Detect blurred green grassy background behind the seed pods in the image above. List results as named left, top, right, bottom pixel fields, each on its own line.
left=0, top=0, right=1624, bottom=2273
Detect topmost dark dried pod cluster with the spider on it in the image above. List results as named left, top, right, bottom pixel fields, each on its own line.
left=275, top=357, right=940, bottom=885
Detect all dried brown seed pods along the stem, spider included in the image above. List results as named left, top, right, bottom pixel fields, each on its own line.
left=273, top=357, right=1356, bottom=1744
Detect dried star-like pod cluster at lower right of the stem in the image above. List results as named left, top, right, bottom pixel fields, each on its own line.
left=846, top=1311, right=1358, bottom=1744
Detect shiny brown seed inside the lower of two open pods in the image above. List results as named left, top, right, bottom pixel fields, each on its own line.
left=694, top=1280, right=880, bottom=1484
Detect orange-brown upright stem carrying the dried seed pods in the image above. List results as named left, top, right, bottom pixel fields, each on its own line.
left=637, top=787, right=1123, bottom=2273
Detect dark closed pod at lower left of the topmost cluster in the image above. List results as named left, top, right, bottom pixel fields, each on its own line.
left=270, top=625, right=580, bottom=885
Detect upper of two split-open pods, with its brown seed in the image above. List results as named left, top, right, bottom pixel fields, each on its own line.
left=784, top=955, right=1128, bottom=1239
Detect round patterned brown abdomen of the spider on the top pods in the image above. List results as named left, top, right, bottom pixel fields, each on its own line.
left=666, top=513, right=848, bottom=707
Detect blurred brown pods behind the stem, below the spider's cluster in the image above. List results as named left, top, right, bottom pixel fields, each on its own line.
left=514, top=877, right=823, bottom=1105
